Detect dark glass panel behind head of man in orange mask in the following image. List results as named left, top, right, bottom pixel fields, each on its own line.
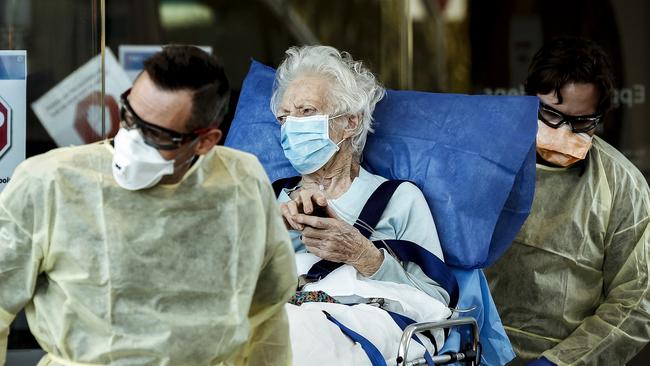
left=468, top=0, right=650, bottom=183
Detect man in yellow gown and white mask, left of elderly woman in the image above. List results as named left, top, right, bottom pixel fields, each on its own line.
left=0, top=46, right=296, bottom=365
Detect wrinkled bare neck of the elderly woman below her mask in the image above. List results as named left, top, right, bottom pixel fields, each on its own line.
left=302, top=153, right=360, bottom=198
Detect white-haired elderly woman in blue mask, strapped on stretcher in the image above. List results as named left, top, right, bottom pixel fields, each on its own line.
left=271, top=46, right=450, bottom=365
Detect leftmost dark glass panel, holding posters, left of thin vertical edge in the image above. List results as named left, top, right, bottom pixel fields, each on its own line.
left=0, top=0, right=102, bottom=358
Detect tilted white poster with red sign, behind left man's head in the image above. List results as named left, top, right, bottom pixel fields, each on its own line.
left=32, top=49, right=131, bottom=146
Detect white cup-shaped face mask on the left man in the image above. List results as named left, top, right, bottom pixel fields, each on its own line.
left=112, top=128, right=174, bottom=191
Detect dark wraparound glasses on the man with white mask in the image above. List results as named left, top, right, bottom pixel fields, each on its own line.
left=120, top=88, right=209, bottom=150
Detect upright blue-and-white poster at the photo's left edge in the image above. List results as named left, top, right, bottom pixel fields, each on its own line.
left=0, top=50, right=27, bottom=191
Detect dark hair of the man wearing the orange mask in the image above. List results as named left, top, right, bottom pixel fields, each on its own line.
left=524, top=37, right=614, bottom=113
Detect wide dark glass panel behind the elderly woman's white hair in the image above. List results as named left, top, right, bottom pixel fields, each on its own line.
left=106, top=0, right=469, bottom=136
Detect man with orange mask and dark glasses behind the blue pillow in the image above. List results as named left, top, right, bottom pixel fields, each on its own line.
left=486, top=37, right=650, bottom=365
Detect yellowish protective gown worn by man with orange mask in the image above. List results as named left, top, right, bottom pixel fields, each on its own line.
left=486, top=137, right=650, bottom=365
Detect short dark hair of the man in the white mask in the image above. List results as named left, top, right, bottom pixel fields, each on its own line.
left=144, top=45, right=230, bottom=131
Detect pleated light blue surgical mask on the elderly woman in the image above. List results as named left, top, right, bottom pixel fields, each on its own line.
left=280, top=115, right=345, bottom=175
